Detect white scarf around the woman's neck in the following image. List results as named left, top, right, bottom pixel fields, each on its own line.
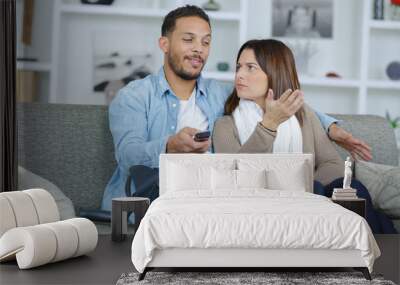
left=232, top=99, right=303, bottom=153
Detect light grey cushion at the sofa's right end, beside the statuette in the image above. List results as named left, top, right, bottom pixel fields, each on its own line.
left=355, top=161, right=400, bottom=219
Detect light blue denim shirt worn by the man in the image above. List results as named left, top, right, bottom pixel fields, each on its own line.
left=102, top=68, right=335, bottom=210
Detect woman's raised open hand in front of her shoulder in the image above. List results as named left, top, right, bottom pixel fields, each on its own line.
left=261, top=89, right=304, bottom=131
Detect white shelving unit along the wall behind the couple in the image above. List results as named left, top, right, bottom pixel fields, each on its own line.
left=17, top=0, right=400, bottom=116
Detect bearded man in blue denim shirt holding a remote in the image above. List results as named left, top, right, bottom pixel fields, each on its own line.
left=102, top=5, right=370, bottom=210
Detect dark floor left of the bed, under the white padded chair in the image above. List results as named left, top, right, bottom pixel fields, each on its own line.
left=0, top=235, right=134, bottom=285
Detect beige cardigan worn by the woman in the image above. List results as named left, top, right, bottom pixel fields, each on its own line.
left=212, top=106, right=344, bottom=185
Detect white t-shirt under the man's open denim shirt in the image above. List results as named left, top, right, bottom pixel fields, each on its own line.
left=176, top=88, right=208, bottom=132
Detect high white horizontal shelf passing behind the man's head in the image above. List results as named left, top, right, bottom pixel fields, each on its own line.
left=60, top=4, right=241, bottom=21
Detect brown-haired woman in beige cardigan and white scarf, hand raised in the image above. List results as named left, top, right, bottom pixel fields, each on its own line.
left=213, top=40, right=396, bottom=233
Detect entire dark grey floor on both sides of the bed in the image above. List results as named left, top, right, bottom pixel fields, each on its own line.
left=0, top=235, right=400, bottom=285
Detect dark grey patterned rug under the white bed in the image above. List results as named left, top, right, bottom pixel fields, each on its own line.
left=117, top=272, right=395, bottom=285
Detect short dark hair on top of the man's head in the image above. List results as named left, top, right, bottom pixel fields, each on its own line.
left=161, top=5, right=211, bottom=37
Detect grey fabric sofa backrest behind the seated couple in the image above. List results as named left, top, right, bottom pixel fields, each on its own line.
left=17, top=103, right=399, bottom=222
